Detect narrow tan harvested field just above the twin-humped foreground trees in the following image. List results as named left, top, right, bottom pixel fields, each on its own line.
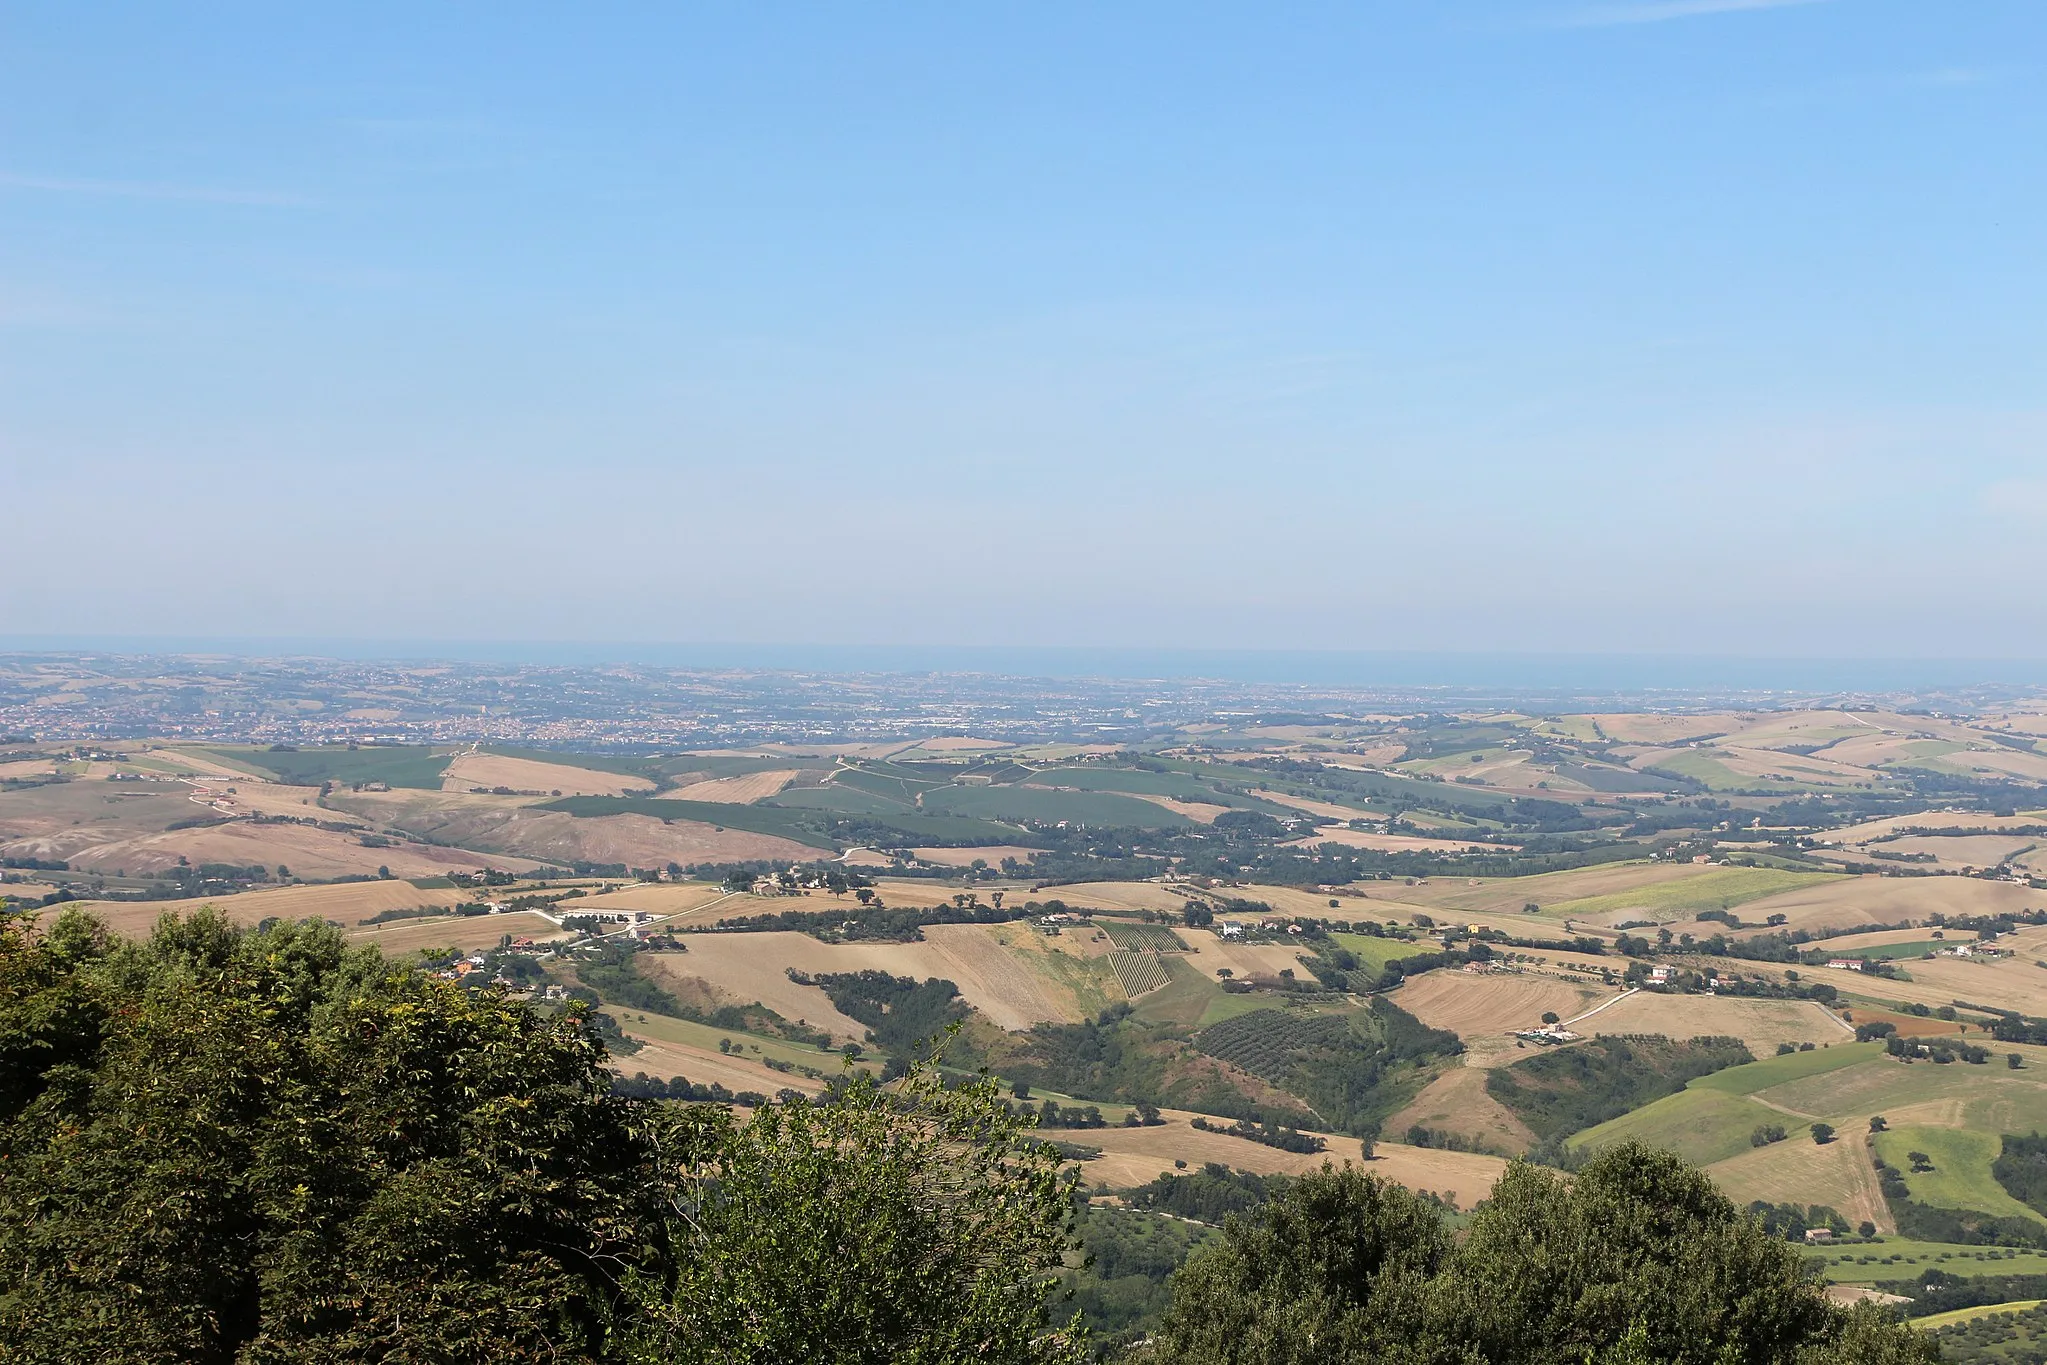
left=1073, top=1109, right=1507, bottom=1209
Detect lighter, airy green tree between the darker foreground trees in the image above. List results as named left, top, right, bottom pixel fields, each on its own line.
left=624, top=1072, right=1085, bottom=1365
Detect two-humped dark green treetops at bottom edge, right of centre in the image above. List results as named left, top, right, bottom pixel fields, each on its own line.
left=1159, top=1144, right=1939, bottom=1365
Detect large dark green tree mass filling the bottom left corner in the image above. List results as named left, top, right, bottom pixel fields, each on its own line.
left=0, top=911, right=641, bottom=1363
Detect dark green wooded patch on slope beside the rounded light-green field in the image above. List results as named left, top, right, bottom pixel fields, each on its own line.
left=1486, top=1033, right=1752, bottom=1140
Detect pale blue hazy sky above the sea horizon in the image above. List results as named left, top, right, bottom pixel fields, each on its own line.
left=0, top=0, right=2047, bottom=657
